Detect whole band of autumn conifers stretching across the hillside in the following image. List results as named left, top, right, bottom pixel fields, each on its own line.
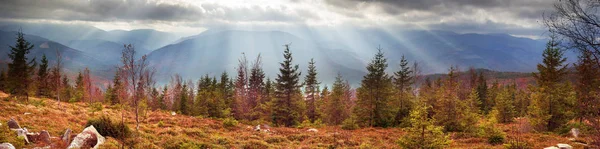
left=0, top=28, right=600, bottom=148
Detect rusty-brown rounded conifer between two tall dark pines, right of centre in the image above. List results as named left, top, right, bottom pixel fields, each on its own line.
left=322, top=74, right=350, bottom=125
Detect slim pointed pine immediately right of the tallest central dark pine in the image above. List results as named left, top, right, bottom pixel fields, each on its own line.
left=304, top=59, right=321, bottom=123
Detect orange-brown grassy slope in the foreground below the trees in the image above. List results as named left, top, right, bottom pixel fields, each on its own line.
left=0, top=93, right=582, bottom=149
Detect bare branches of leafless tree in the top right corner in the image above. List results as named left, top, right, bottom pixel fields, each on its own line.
left=544, top=0, right=600, bottom=66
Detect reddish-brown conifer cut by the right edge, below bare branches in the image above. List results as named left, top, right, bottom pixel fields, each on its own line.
left=575, top=51, right=600, bottom=122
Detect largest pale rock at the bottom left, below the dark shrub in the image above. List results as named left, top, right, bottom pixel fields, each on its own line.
left=67, top=125, right=104, bottom=149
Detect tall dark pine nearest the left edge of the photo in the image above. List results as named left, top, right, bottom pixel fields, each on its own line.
left=8, top=30, right=35, bottom=100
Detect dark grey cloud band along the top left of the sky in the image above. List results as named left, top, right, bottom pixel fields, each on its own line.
left=0, top=0, right=202, bottom=21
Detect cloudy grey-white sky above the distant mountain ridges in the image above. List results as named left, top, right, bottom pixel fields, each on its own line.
left=0, top=0, right=558, bottom=38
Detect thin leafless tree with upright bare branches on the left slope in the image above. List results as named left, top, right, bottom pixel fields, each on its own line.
left=121, top=44, right=148, bottom=130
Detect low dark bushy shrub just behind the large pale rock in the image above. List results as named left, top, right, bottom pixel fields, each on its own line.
left=85, top=116, right=131, bottom=139
